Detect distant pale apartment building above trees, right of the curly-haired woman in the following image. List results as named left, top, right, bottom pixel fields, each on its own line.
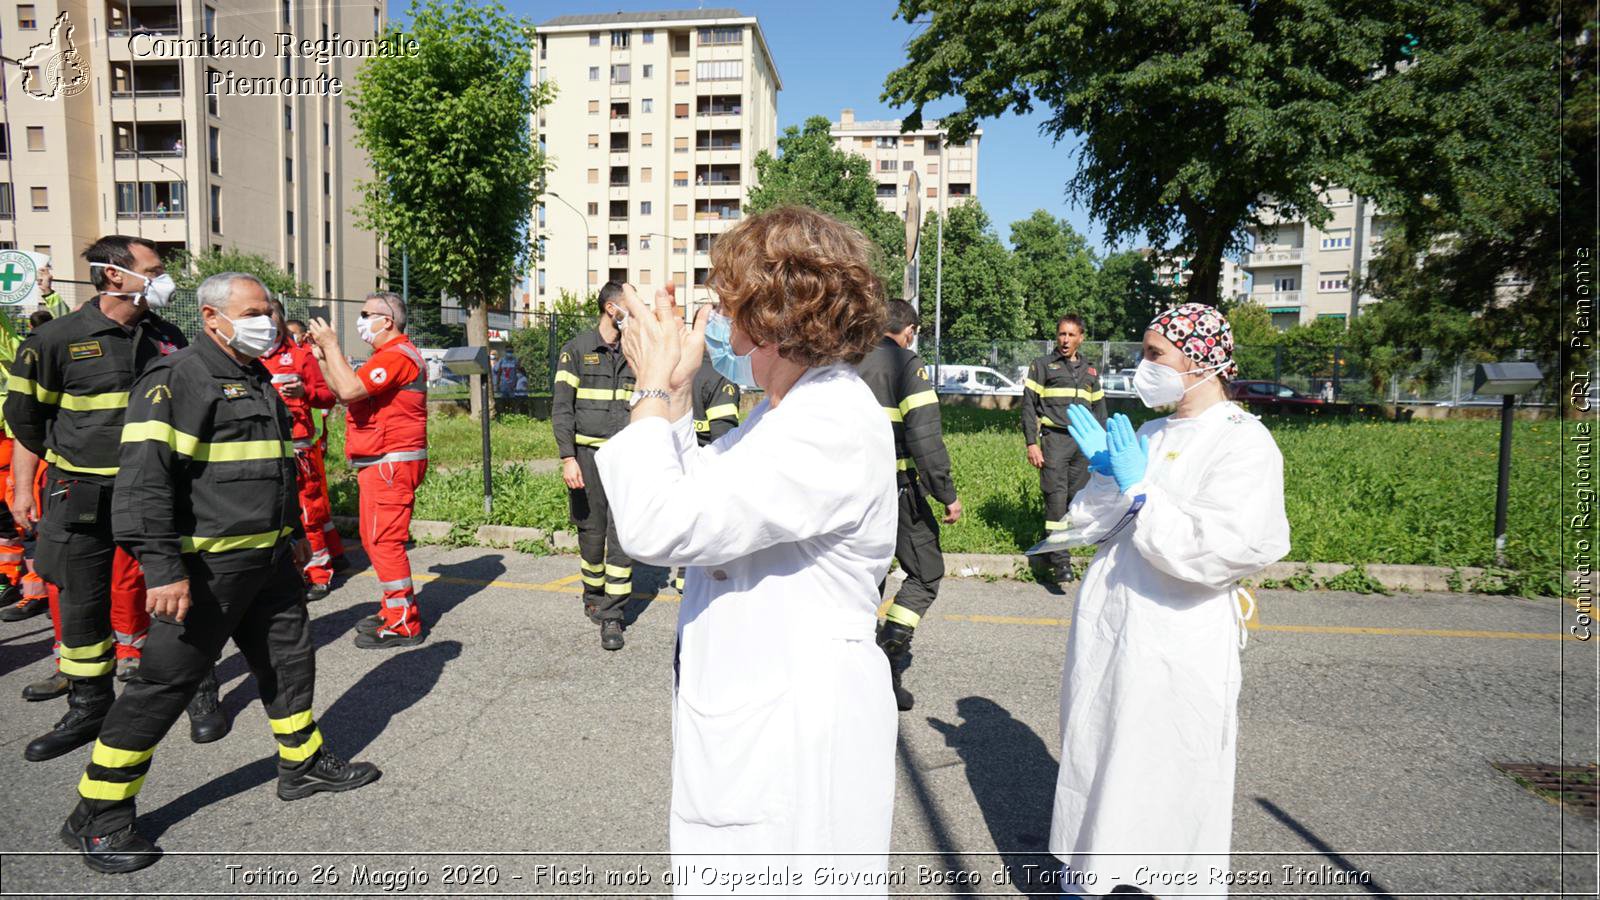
left=829, top=109, right=982, bottom=218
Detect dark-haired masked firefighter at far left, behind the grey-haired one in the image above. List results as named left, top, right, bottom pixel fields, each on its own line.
left=5, top=235, right=229, bottom=762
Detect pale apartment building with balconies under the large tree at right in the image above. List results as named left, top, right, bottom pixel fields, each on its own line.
left=1243, top=187, right=1386, bottom=328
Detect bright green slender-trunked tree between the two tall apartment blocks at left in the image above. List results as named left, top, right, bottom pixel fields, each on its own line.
left=349, top=0, right=554, bottom=415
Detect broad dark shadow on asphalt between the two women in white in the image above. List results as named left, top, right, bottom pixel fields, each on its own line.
left=928, top=697, right=1061, bottom=897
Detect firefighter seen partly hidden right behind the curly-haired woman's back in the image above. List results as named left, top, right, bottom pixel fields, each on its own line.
left=856, top=299, right=962, bottom=711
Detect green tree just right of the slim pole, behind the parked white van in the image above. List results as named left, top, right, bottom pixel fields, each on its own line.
left=918, top=200, right=1035, bottom=365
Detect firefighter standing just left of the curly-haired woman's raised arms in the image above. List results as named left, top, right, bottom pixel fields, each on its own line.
left=550, top=282, right=634, bottom=650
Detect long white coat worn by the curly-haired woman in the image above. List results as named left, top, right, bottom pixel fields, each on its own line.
left=595, top=365, right=898, bottom=894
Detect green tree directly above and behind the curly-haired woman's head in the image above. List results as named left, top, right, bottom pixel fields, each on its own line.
left=744, top=115, right=908, bottom=288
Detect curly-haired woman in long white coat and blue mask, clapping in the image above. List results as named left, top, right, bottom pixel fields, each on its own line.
left=595, top=207, right=898, bottom=895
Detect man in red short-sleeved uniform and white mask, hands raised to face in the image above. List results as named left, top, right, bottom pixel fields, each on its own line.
left=310, top=291, right=427, bottom=649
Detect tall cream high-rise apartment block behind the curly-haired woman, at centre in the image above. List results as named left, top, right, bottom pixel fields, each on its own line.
left=530, top=10, right=782, bottom=312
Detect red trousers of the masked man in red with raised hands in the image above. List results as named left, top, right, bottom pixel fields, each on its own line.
left=355, top=460, right=427, bottom=637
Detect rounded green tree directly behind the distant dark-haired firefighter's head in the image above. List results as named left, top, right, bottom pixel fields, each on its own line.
left=1011, top=210, right=1104, bottom=340
